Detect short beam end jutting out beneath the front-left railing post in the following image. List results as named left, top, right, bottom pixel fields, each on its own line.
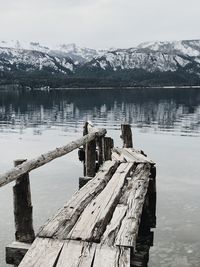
left=6, top=241, right=31, bottom=266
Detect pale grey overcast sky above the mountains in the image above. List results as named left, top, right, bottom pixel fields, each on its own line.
left=0, top=0, right=200, bottom=48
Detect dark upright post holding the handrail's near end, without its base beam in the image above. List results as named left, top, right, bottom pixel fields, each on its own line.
left=13, top=160, right=35, bottom=243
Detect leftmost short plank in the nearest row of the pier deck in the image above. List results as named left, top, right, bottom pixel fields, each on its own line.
left=19, top=238, right=63, bottom=267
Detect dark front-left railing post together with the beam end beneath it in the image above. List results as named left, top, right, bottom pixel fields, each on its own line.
left=6, top=160, right=35, bottom=267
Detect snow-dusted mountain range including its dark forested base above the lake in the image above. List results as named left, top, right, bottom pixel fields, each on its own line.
left=0, top=40, right=200, bottom=88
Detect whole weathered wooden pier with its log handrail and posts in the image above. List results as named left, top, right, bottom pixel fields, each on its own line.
left=0, top=123, right=156, bottom=267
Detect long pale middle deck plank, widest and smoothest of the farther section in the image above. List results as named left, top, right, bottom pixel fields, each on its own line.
left=68, top=163, right=134, bottom=242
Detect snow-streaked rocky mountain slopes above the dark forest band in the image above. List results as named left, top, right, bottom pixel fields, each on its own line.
left=0, top=40, right=200, bottom=86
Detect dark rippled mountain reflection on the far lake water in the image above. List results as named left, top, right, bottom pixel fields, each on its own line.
left=0, top=88, right=200, bottom=135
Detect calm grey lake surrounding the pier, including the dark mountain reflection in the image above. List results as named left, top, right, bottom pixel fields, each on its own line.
left=0, top=88, right=200, bottom=267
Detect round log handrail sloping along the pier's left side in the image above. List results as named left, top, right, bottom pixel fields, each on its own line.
left=0, top=129, right=106, bottom=187
